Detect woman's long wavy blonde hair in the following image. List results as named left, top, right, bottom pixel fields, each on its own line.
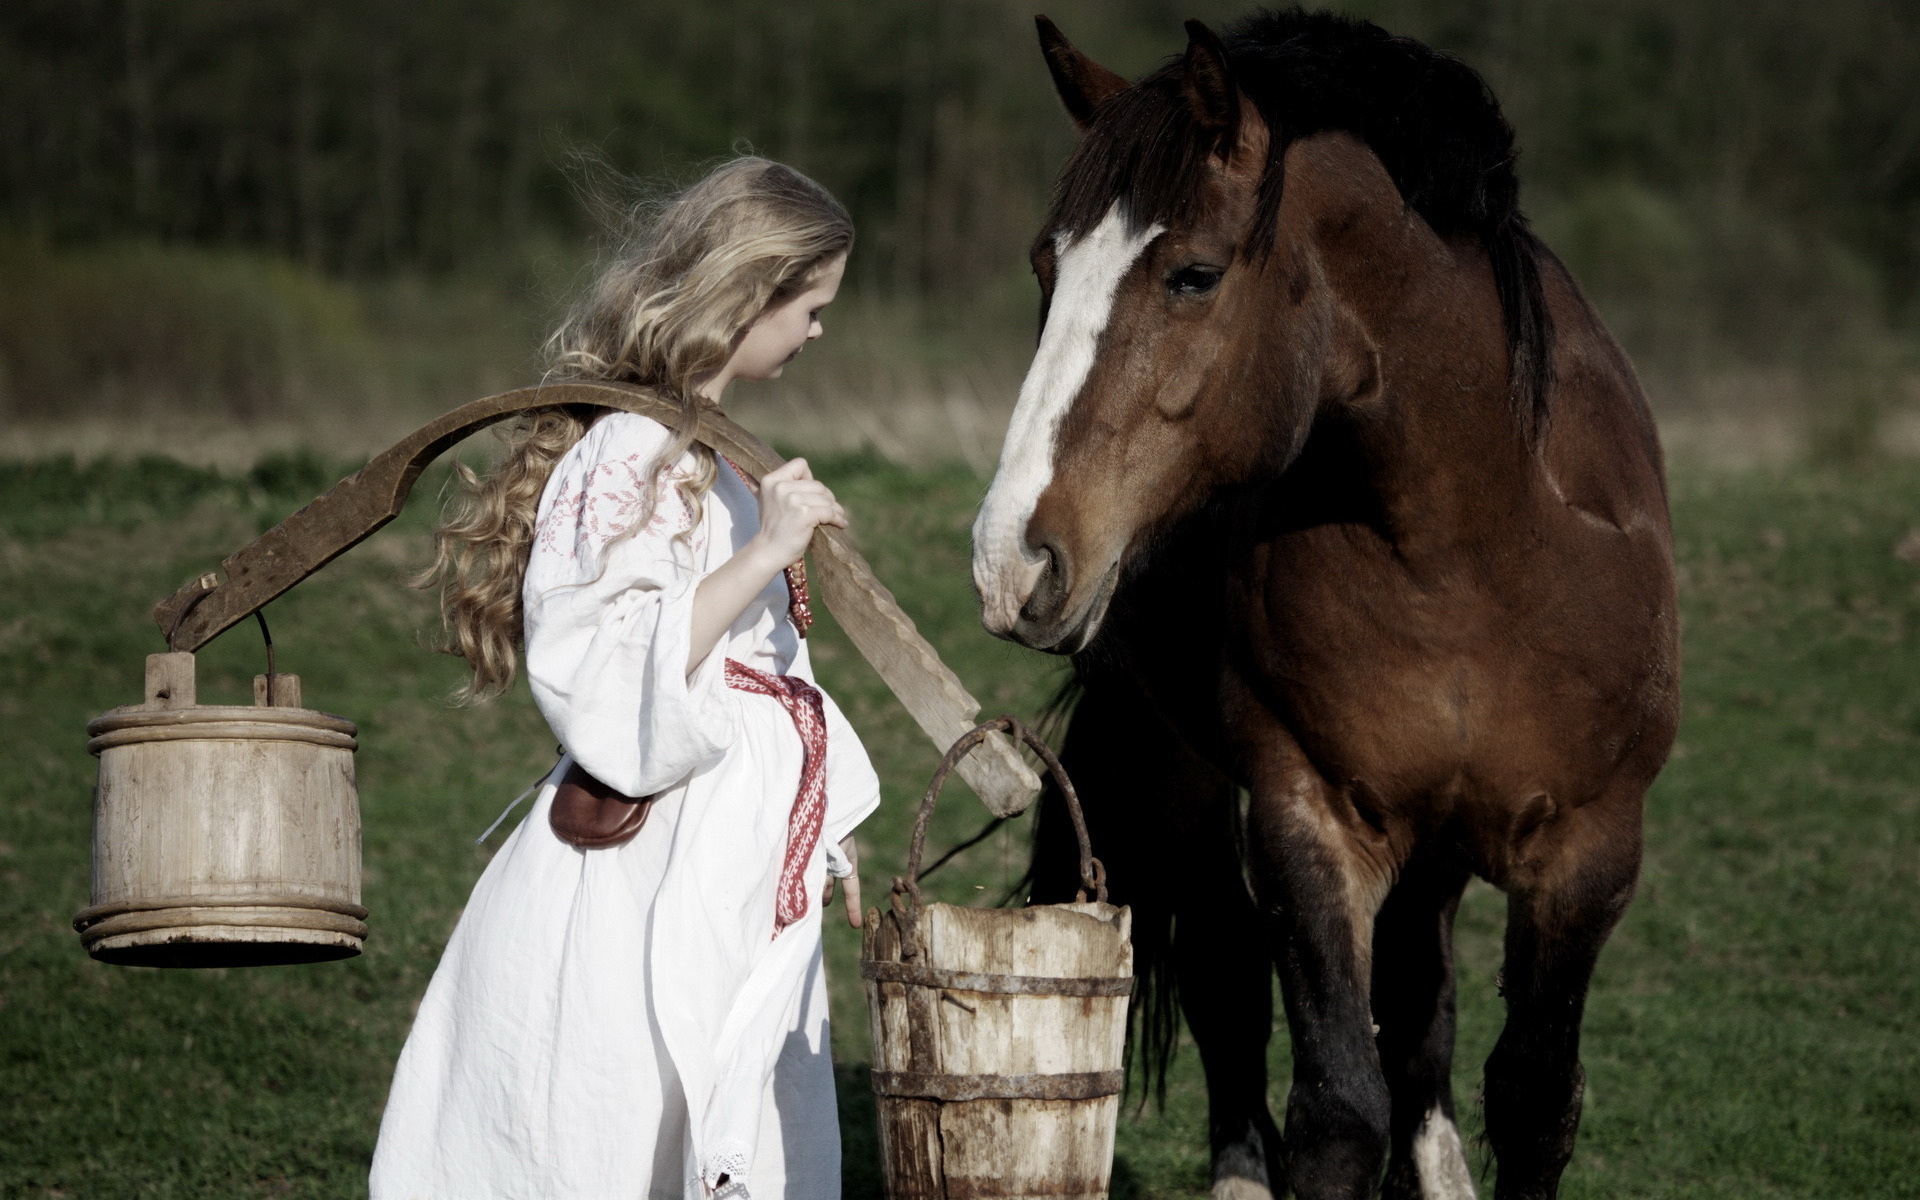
left=424, top=156, right=852, bottom=703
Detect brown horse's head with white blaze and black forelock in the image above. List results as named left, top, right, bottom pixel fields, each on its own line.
left=973, top=17, right=1538, bottom=653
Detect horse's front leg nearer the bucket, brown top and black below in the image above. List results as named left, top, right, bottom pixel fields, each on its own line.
left=1248, top=730, right=1394, bottom=1200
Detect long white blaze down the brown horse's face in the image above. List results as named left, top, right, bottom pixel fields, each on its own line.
left=973, top=204, right=1165, bottom=634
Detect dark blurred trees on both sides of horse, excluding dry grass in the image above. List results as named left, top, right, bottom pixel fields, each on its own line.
left=0, top=0, right=1920, bottom=416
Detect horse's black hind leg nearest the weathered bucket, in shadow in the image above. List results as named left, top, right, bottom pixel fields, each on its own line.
left=1033, top=674, right=1281, bottom=1200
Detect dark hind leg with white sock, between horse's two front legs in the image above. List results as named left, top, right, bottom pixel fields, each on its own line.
left=1373, top=854, right=1475, bottom=1200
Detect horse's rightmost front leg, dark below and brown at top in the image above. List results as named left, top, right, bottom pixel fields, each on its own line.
left=1486, top=795, right=1640, bottom=1200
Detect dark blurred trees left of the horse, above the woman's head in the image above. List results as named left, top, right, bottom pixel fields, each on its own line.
left=0, top=0, right=1121, bottom=292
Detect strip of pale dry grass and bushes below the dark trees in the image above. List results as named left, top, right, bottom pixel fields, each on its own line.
left=0, top=240, right=1920, bottom=472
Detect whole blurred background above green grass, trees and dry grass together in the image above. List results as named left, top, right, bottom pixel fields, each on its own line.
left=0, top=0, right=1920, bottom=458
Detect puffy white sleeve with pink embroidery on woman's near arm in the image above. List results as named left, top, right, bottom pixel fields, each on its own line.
left=520, top=413, right=735, bottom=797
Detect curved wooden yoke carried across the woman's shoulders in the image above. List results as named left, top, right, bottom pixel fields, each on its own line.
left=154, top=382, right=1041, bottom=816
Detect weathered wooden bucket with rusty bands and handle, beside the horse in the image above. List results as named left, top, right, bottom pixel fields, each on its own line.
left=860, top=716, right=1133, bottom=1200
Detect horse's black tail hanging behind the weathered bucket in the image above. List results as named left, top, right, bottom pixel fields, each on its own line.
left=1023, top=664, right=1179, bottom=1104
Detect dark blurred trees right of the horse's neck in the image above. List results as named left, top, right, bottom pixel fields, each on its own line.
left=1365, top=0, right=1920, bottom=369
